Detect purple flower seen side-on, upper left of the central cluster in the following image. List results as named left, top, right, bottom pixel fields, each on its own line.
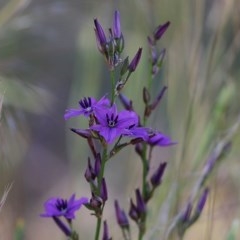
left=64, top=96, right=110, bottom=120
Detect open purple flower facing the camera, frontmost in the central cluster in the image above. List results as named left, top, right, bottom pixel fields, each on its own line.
left=91, top=104, right=138, bottom=143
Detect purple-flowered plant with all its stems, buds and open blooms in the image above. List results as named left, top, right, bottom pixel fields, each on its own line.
left=41, top=11, right=236, bottom=240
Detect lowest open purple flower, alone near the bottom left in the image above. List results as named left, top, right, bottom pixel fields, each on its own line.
left=41, top=194, right=88, bottom=219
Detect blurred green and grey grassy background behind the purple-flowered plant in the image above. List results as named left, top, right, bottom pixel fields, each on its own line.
left=0, top=0, right=240, bottom=240
